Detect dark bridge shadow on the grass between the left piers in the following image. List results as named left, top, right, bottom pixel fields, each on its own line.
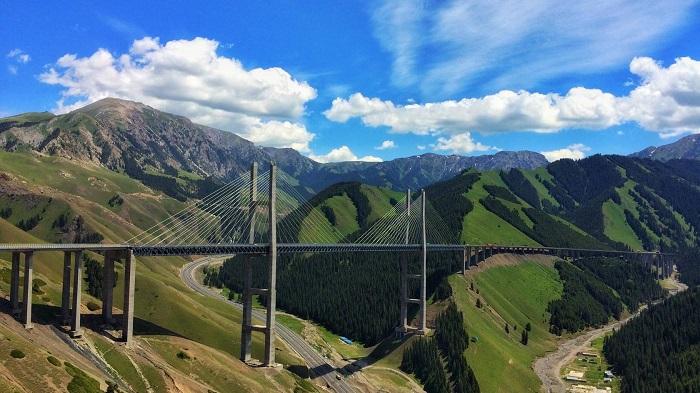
left=0, top=297, right=186, bottom=342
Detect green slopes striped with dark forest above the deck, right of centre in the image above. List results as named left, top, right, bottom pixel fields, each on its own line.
left=300, top=155, right=700, bottom=250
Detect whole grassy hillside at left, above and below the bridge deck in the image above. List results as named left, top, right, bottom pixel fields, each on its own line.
left=0, top=152, right=308, bottom=391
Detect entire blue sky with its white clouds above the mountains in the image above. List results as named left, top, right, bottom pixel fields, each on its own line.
left=0, top=0, right=700, bottom=161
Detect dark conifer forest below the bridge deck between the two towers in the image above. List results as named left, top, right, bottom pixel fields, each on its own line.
left=216, top=252, right=461, bottom=345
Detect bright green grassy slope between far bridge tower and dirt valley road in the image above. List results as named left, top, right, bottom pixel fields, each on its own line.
left=450, top=262, right=563, bottom=393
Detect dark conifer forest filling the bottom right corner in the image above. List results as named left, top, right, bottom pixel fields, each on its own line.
left=603, top=287, right=700, bottom=393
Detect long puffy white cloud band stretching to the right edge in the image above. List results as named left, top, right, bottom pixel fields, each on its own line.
left=324, top=57, right=700, bottom=137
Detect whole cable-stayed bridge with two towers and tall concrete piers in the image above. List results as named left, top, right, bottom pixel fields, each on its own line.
left=0, top=164, right=673, bottom=365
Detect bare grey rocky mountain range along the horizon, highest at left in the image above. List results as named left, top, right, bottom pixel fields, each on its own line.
left=0, top=98, right=547, bottom=199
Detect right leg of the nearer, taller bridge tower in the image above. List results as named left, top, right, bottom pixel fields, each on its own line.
left=264, top=163, right=277, bottom=367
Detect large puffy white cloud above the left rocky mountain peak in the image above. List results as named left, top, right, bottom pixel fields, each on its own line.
left=39, top=37, right=316, bottom=152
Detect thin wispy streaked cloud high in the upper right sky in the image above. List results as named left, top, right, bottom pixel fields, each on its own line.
left=373, top=0, right=697, bottom=96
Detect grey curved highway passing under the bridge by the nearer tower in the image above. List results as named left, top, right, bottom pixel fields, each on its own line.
left=180, top=257, right=355, bottom=393
